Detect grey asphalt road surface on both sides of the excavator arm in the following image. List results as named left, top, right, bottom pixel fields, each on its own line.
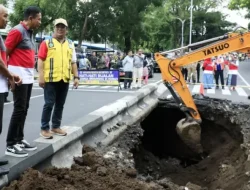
left=0, top=60, right=250, bottom=156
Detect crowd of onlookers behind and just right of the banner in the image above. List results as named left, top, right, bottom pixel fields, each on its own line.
left=77, top=49, right=149, bottom=90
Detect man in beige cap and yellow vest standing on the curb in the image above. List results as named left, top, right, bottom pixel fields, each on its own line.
left=38, top=18, right=79, bottom=139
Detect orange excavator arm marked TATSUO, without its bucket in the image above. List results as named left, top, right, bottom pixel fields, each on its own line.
left=155, top=32, right=250, bottom=122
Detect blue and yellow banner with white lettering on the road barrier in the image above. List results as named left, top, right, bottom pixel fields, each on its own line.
left=78, top=70, right=119, bottom=86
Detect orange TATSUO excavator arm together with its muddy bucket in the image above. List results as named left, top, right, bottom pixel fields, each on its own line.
left=155, top=28, right=250, bottom=154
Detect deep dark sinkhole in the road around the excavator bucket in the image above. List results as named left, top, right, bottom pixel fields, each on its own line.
left=132, top=107, right=247, bottom=190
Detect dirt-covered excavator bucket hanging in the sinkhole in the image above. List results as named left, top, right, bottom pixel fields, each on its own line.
left=176, top=118, right=203, bottom=154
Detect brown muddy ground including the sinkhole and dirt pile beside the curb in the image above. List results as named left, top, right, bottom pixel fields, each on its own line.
left=4, top=96, right=250, bottom=190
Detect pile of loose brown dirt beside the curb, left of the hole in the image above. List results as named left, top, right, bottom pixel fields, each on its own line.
left=3, top=128, right=168, bottom=190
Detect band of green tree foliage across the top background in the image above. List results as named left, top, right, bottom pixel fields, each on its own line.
left=8, top=0, right=236, bottom=51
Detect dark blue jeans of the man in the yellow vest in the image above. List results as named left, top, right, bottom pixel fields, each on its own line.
left=41, top=80, right=69, bottom=130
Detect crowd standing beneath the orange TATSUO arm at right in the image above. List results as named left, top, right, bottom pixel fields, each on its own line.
left=182, top=53, right=244, bottom=90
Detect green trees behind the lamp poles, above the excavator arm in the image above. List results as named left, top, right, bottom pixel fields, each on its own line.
left=143, top=0, right=234, bottom=51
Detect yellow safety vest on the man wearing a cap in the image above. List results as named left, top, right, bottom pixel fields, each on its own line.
left=44, top=38, right=73, bottom=82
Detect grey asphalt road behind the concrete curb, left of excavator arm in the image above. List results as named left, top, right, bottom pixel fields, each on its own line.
left=0, top=74, right=161, bottom=156
